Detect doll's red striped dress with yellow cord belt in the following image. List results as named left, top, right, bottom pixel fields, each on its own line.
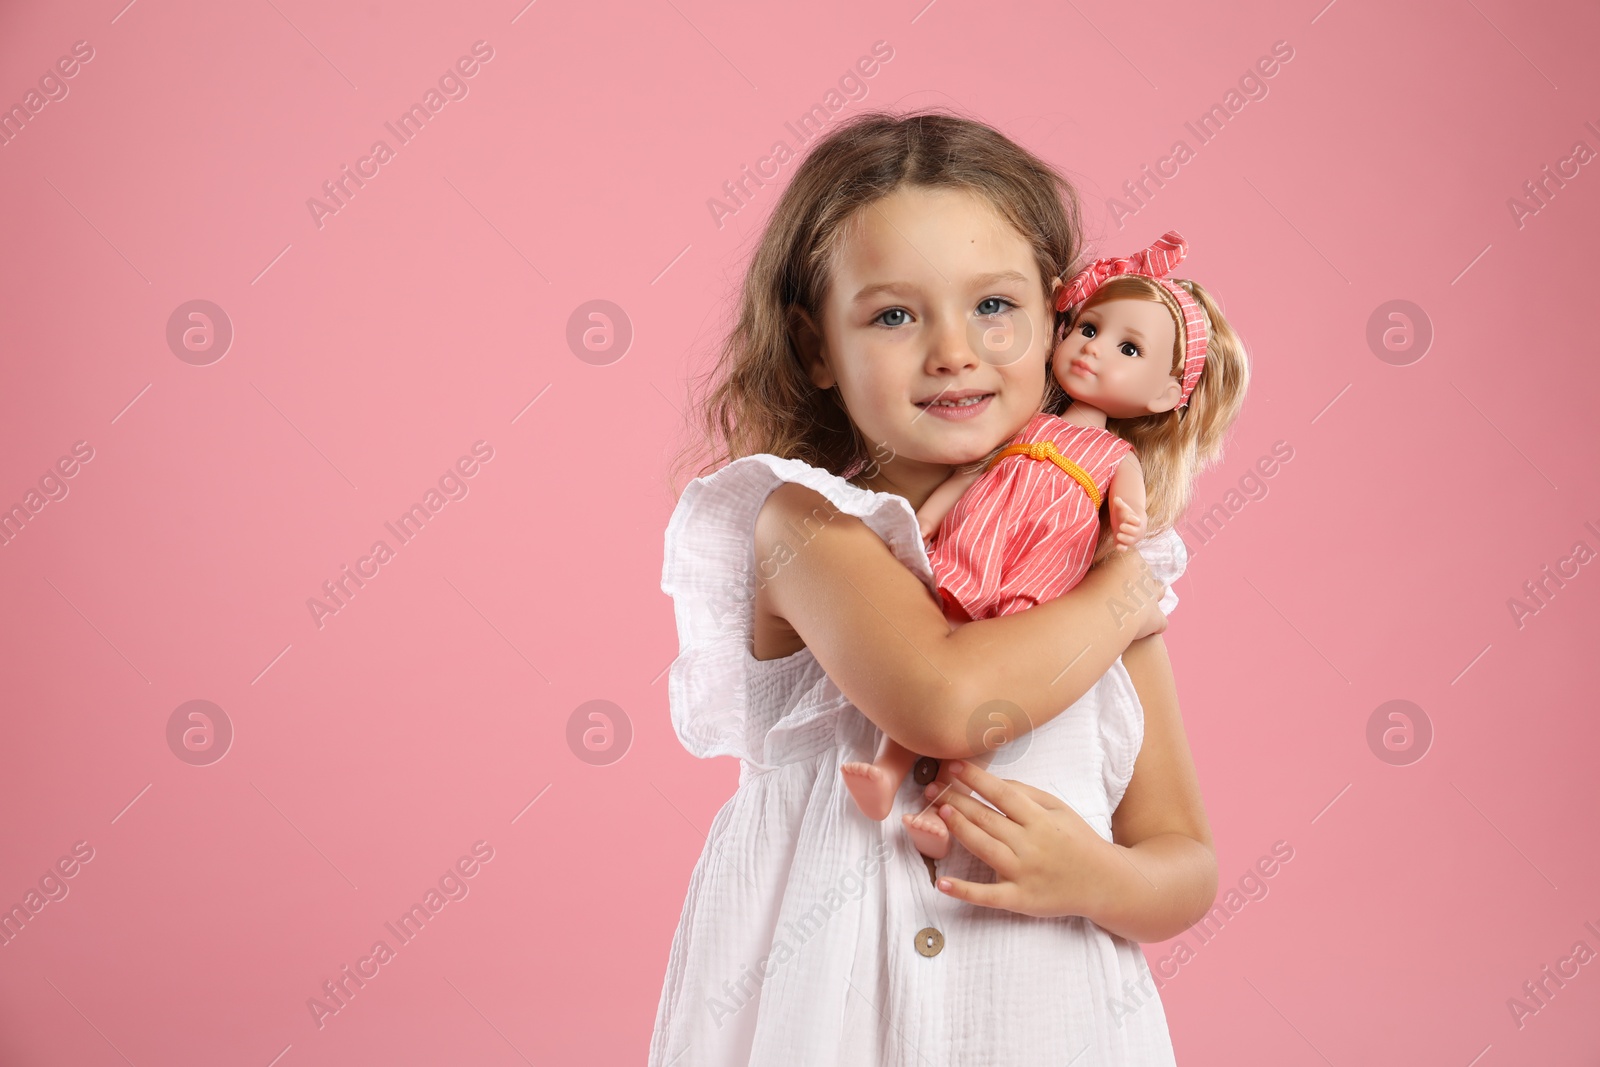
left=928, top=413, right=1133, bottom=619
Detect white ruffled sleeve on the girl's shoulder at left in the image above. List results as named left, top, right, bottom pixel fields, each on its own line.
left=661, top=454, right=938, bottom=763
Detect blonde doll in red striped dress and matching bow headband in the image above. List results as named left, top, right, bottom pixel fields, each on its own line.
left=842, top=232, right=1248, bottom=859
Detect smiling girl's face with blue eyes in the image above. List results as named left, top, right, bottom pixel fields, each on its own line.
left=797, top=186, right=1053, bottom=502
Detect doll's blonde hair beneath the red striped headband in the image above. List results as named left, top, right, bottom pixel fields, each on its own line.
left=1061, top=275, right=1250, bottom=558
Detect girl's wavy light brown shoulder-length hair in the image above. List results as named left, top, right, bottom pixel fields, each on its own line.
left=669, top=112, right=1082, bottom=485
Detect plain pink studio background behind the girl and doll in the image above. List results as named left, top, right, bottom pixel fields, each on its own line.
left=0, top=0, right=1600, bottom=1067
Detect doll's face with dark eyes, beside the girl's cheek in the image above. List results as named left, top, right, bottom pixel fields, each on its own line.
left=1053, top=298, right=1182, bottom=419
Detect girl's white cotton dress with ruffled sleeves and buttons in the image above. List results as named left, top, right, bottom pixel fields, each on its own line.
left=650, top=454, right=1187, bottom=1067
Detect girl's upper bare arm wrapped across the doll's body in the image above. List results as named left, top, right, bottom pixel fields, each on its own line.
left=755, top=483, right=1165, bottom=758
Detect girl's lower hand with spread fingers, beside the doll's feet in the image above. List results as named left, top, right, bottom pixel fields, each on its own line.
left=926, top=760, right=1128, bottom=920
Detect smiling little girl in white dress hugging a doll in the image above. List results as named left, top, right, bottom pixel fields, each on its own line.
left=650, top=114, right=1216, bottom=1067
